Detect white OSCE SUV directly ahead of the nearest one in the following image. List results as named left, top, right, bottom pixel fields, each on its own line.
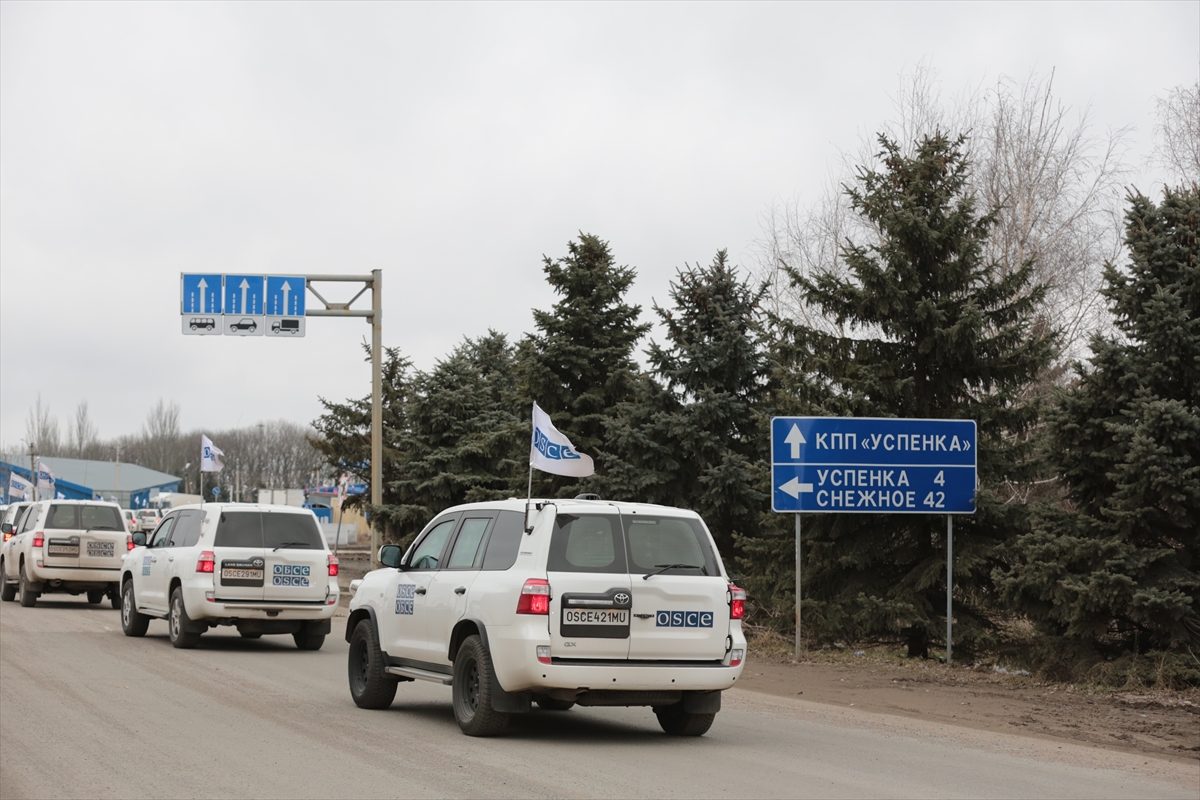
left=120, top=503, right=338, bottom=650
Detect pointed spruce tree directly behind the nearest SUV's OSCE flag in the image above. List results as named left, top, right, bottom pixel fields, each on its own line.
left=514, top=234, right=649, bottom=497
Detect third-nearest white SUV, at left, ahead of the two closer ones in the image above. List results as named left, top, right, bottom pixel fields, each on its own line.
left=0, top=500, right=132, bottom=608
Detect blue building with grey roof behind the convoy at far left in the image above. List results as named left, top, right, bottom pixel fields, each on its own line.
left=0, top=453, right=182, bottom=509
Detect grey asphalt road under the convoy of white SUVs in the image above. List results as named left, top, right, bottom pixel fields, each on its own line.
left=0, top=599, right=1200, bottom=799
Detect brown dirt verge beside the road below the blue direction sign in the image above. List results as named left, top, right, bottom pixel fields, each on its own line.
left=738, top=648, right=1200, bottom=763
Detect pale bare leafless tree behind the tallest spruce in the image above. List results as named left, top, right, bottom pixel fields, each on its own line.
left=758, top=65, right=1128, bottom=360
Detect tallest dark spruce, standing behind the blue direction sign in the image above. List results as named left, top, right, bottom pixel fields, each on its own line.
left=768, top=134, right=1054, bottom=656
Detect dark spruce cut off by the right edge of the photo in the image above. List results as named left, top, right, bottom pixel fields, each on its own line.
left=997, top=185, right=1200, bottom=654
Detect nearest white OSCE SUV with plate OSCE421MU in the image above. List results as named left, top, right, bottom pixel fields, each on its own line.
left=346, top=495, right=745, bottom=736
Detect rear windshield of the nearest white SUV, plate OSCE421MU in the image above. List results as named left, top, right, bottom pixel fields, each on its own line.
left=546, top=513, right=720, bottom=576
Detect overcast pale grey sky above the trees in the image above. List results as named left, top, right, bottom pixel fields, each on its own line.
left=0, top=0, right=1200, bottom=445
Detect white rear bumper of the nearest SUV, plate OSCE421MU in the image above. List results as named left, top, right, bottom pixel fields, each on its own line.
left=487, top=618, right=745, bottom=692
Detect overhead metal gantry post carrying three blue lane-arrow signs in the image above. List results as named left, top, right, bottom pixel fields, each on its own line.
left=180, top=270, right=383, bottom=567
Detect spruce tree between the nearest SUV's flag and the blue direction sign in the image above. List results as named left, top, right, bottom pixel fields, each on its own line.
left=599, top=251, right=768, bottom=555
